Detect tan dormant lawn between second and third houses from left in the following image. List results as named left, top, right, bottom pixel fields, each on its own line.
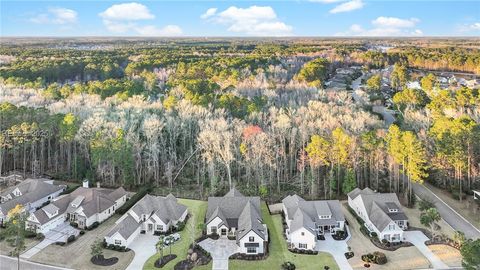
left=30, top=215, right=134, bottom=270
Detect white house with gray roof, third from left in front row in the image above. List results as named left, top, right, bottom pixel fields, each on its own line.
left=105, top=194, right=188, bottom=247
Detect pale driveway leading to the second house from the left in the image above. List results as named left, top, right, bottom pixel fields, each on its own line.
left=20, top=222, right=80, bottom=259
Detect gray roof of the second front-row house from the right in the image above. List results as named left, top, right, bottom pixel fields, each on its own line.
left=282, top=195, right=345, bottom=233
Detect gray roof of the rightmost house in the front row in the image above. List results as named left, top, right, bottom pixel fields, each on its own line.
left=348, top=190, right=408, bottom=231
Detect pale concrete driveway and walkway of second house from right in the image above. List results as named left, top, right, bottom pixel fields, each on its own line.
left=316, top=227, right=353, bottom=270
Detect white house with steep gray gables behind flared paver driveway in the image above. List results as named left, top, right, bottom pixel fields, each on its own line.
left=205, top=188, right=268, bottom=255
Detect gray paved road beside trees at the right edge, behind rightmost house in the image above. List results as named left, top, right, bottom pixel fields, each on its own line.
left=413, top=183, right=480, bottom=239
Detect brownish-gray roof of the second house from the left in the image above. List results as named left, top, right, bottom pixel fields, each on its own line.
left=33, top=187, right=127, bottom=224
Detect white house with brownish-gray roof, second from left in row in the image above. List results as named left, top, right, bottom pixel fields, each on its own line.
left=27, top=183, right=127, bottom=234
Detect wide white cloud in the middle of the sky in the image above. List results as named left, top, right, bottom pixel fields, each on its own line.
left=202, top=6, right=293, bottom=36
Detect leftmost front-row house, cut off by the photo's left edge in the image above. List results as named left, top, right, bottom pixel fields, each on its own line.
left=0, top=179, right=66, bottom=224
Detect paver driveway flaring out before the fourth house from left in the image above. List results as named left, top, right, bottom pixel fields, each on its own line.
left=198, top=238, right=239, bottom=270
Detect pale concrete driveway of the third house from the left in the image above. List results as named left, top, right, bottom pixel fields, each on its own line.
left=127, top=234, right=159, bottom=270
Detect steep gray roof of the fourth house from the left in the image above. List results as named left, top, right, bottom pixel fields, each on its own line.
left=206, top=188, right=266, bottom=241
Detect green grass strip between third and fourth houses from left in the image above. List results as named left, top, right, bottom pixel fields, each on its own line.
left=143, top=199, right=207, bottom=269
